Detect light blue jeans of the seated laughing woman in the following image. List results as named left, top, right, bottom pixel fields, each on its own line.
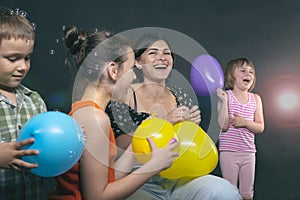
left=128, top=175, right=242, bottom=200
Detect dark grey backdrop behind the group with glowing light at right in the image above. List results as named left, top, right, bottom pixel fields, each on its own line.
left=0, top=0, right=300, bottom=200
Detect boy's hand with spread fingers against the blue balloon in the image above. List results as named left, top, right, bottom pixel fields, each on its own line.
left=0, top=138, right=39, bottom=171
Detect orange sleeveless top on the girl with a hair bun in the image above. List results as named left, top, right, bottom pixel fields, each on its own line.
left=48, top=101, right=117, bottom=200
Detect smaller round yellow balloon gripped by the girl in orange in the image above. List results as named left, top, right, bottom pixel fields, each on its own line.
left=132, top=117, right=178, bottom=163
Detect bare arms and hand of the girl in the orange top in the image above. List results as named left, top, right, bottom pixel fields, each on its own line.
left=79, top=110, right=178, bottom=200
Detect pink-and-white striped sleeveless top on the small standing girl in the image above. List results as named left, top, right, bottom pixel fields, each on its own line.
left=219, top=90, right=256, bottom=153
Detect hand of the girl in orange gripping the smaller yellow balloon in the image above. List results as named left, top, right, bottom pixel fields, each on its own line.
left=148, top=138, right=179, bottom=172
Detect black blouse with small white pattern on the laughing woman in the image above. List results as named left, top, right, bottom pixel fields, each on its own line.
left=105, top=85, right=198, bottom=138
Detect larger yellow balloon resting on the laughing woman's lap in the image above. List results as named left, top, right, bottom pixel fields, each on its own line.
left=160, top=121, right=218, bottom=179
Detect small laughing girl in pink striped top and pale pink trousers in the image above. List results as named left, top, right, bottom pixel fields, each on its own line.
left=217, top=58, right=264, bottom=200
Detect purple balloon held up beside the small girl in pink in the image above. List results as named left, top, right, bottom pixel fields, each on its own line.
left=190, top=54, right=224, bottom=96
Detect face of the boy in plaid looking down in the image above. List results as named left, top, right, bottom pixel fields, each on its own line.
left=0, top=38, right=34, bottom=90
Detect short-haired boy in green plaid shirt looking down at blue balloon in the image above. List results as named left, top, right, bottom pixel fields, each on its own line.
left=0, top=7, right=46, bottom=200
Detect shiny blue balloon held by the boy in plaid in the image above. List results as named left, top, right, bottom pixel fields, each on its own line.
left=17, top=111, right=84, bottom=177
